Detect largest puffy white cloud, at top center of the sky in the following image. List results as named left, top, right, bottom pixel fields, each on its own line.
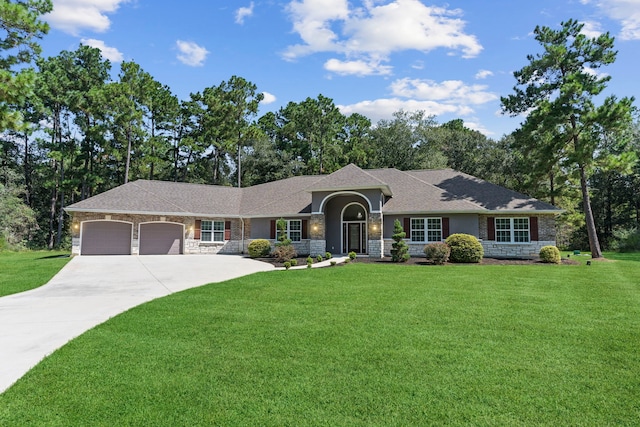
left=283, top=0, right=482, bottom=74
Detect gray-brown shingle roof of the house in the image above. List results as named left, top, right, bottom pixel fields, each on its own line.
left=67, top=164, right=560, bottom=217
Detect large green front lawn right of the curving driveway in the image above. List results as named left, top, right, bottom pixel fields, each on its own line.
left=0, top=254, right=640, bottom=426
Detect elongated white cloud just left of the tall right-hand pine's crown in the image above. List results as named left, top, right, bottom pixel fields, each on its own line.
left=391, top=78, right=498, bottom=105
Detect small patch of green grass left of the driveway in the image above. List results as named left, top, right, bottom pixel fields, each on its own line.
left=0, top=251, right=71, bottom=297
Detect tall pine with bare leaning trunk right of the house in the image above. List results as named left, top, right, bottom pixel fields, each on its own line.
left=501, top=20, right=633, bottom=258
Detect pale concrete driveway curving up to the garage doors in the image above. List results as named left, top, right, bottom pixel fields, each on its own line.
left=0, top=255, right=273, bottom=393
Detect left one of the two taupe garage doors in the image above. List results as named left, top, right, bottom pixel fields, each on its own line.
left=80, top=221, right=133, bottom=255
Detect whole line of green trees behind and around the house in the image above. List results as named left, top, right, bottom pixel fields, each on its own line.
left=0, top=0, right=640, bottom=254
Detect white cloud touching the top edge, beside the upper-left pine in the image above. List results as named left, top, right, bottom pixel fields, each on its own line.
left=44, top=0, right=130, bottom=36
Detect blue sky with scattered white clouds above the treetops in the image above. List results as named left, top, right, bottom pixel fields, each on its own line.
left=42, top=0, right=640, bottom=139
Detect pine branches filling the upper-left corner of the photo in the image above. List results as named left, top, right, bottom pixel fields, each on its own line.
left=0, top=0, right=53, bottom=131
